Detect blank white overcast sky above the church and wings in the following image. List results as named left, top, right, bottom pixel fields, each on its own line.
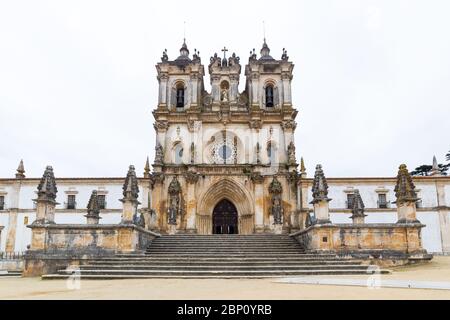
left=0, top=0, right=450, bottom=178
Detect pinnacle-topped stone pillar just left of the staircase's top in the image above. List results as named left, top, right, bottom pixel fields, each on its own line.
left=120, top=166, right=140, bottom=224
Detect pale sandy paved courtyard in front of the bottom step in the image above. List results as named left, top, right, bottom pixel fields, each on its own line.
left=0, top=257, right=450, bottom=300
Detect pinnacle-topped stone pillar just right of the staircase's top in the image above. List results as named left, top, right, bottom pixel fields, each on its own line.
left=311, top=164, right=331, bottom=224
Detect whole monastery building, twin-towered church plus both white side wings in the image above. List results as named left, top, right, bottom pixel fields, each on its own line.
left=0, top=41, right=450, bottom=253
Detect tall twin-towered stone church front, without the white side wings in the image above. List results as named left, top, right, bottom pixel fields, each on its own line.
left=149, top=42, right=298, bottom=234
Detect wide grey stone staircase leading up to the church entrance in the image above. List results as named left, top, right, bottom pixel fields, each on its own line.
left=42, top=234, right=387, bottom=279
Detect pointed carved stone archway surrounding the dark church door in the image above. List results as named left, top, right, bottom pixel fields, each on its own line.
left=196, top=178, right=255, bottom=234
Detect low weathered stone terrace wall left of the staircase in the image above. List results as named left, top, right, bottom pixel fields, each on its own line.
left=23, top=224, right=160, bottom=276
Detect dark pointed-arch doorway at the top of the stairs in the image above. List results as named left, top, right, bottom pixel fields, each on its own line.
left=213, top=199, right=238, bottom=234
